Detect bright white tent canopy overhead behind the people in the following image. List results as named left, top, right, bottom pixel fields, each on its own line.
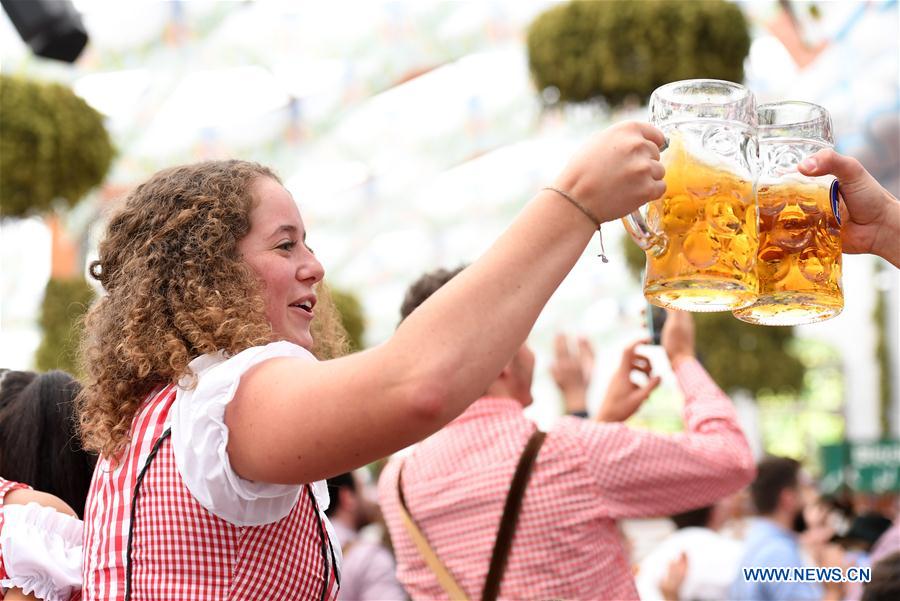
left=0, top=0, right=900, bottom=436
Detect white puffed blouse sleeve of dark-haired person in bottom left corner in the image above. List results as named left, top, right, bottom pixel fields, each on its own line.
left=0, top=503, right=84, bottom=601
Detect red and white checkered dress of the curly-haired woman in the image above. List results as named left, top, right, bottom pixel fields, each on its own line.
left=84, top=386, right=338, bottom=601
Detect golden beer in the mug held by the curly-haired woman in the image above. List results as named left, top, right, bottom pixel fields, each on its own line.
left=644, top=137, right=758, bottom=311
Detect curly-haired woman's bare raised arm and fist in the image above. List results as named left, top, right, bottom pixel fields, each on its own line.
left=225, top=123, right=665, bottom=483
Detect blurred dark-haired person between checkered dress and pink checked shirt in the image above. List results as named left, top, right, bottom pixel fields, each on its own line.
left=325, top=472, right=406, bottom=601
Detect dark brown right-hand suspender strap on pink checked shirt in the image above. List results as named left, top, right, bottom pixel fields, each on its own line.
left=481, top=430, right=547, bottom=601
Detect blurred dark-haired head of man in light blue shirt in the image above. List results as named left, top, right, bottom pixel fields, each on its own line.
left=750, top=457, right=806, bottom=521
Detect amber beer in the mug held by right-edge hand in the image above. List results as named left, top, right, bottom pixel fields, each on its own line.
left=734, top=182, right=844, bottom=325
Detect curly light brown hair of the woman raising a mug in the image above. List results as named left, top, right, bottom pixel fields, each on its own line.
left=77, top=160, right=347, bottom=457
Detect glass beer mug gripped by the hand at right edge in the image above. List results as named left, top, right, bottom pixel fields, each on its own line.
left=734, top=102, right=844, bottom=326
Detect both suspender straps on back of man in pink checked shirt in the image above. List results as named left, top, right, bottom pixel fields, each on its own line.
left=397, top=430, right=546, bottom=601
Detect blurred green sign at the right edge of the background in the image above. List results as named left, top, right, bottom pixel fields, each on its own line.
left=821, top=440, right=900, bottom=493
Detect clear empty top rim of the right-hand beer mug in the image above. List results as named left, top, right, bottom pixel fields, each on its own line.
left=756, top=100, right=834, bottom=146
